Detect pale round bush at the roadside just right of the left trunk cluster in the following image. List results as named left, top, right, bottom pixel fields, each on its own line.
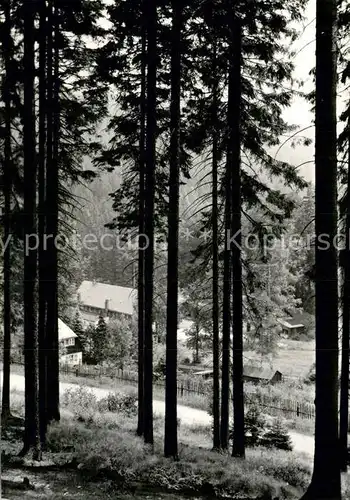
left=62, top=386, right=98, bottom=422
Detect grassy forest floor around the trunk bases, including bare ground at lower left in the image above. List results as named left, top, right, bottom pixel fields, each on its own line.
left=1, top=392, right=311, bottom=500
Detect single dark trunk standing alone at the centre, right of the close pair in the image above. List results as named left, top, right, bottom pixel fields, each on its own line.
left=164, top=0, right=182, bottom=458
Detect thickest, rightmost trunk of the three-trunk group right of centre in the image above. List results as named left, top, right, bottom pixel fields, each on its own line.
left=228, top=13, right=245, bottom=457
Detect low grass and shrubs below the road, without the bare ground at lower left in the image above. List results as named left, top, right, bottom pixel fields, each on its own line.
left=44, top=389, right=310, bottom=499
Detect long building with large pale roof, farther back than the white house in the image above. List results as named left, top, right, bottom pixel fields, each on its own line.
left=77, top=281, right=136, bottom=324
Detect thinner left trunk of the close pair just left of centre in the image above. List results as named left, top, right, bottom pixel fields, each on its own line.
left=137, top=0, right=146, bottom=436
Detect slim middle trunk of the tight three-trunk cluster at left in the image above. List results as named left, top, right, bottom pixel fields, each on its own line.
left=38, top=0, right=48, bottom=444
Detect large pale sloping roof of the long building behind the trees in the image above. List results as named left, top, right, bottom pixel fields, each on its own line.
left=77, top=281, right=135, bottom=316
